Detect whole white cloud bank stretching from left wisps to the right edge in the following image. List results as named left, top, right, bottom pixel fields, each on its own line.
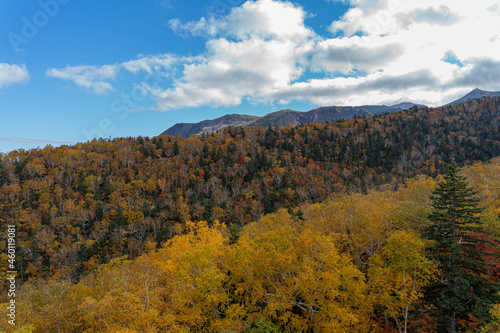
left=48, top=0, right=500, bottom=110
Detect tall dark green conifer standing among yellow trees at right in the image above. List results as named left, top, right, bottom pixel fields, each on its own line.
left=425, top=163, right=500, bottom=333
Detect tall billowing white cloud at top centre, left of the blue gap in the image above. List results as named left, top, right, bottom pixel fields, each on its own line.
left=158, top=0, right=314, bottom=110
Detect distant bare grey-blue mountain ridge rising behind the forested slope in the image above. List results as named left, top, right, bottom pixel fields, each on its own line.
left=161, top=88, right=500, bottom=137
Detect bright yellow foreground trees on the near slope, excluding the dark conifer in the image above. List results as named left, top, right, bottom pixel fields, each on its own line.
left=2, top=158, right=500, bottom=333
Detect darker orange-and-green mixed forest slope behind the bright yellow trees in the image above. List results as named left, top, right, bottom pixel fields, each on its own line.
left=0, top=98, right=500, bottom=280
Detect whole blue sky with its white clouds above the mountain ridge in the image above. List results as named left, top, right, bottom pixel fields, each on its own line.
left=0, top=0, right=500, bottom=153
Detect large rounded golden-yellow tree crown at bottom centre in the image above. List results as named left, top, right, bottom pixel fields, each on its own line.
left=229, top=210, right=369, bottom=332
